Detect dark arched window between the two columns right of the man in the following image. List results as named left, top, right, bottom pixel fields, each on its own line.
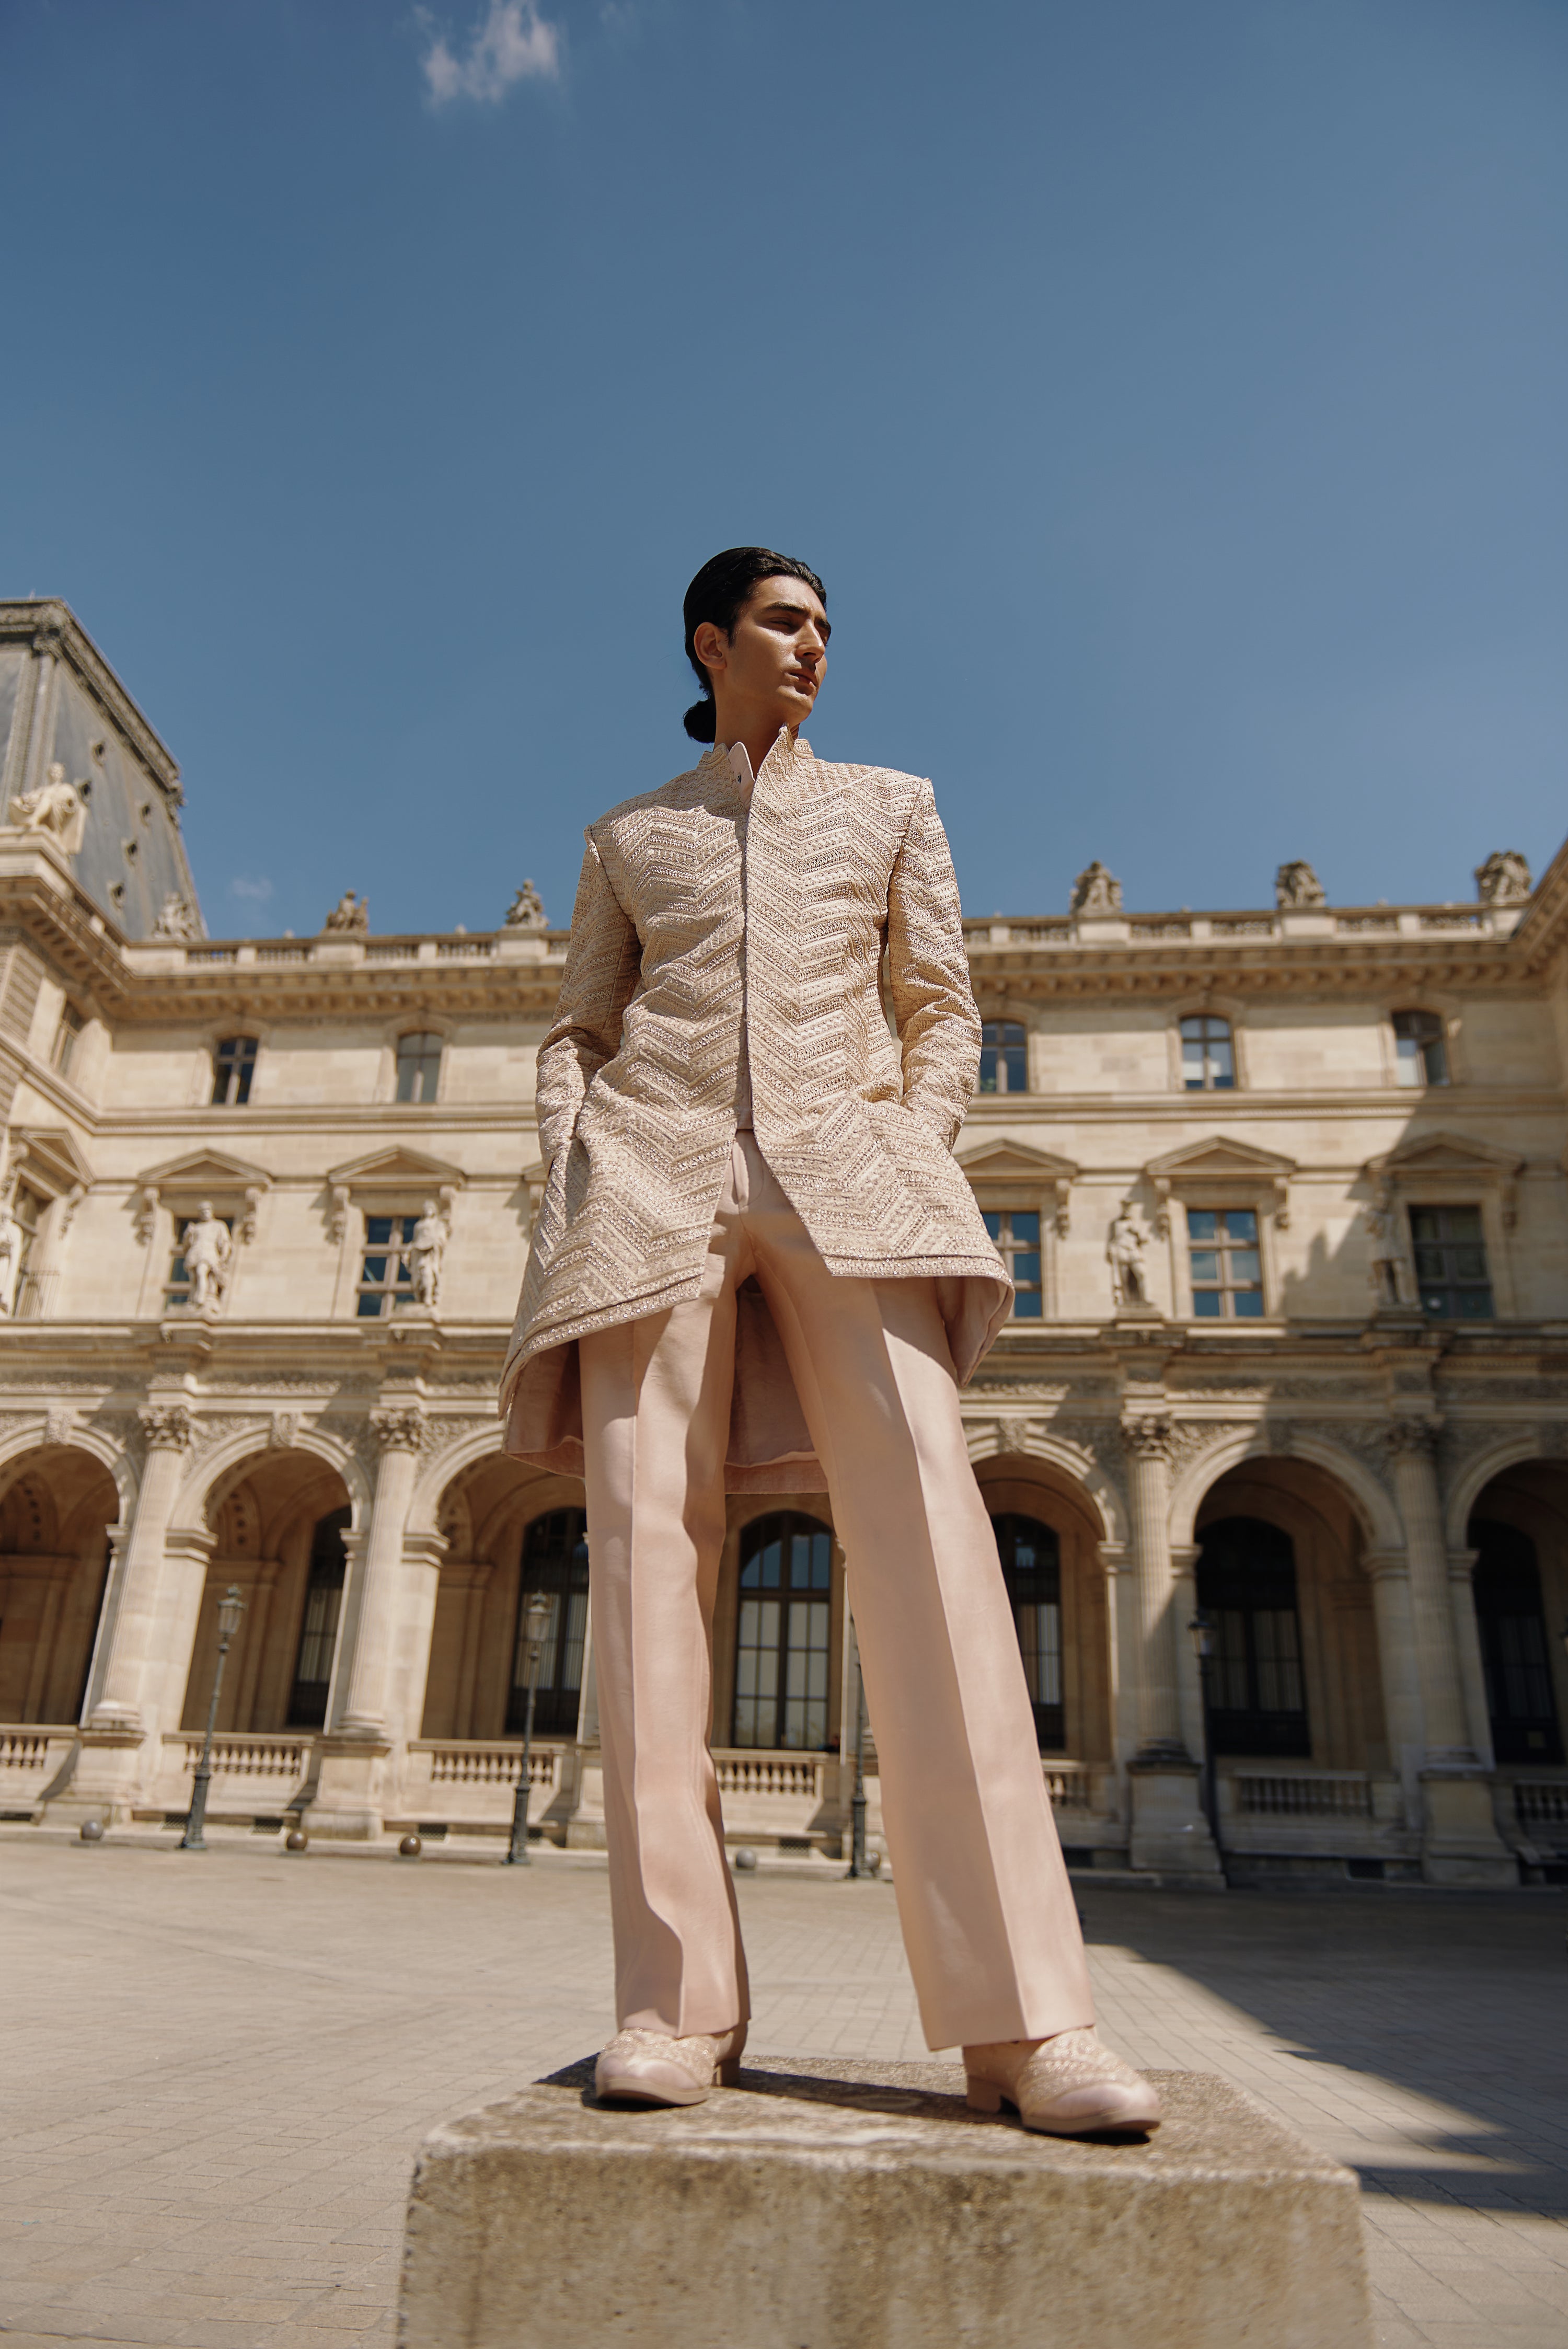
left=1197, top=1517, right=1312, bottom=1757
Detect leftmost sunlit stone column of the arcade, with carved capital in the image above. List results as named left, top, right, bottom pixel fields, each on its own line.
left=47, top=1402, right=192, bottom=1825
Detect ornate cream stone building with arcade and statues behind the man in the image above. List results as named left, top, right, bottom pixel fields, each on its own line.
left=0, top=601, right=1568, bottom=1884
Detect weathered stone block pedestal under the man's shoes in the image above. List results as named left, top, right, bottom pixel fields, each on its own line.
left=399, top=2060, right=1371, bottom=2349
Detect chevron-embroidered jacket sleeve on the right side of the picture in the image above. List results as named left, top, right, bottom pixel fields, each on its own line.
left=887, top=782, right=981, bottom=1149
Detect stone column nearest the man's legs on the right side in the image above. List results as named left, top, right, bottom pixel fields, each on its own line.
left=1122, top=1417, right=1223, bottom=1884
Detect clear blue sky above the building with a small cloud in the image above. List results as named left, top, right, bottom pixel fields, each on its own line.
left=0, top=0, right=1568, bottom=935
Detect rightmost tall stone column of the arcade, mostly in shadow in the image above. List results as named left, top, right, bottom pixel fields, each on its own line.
left=1387, top=1419, right=1519, bottom=1884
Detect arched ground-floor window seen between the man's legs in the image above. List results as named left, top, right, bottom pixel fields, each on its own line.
left=732, top=1508, right=833, bottom=1753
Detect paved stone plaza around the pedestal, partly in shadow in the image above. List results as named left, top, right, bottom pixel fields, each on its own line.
left=0, top=1835, right=1568, bottom=2349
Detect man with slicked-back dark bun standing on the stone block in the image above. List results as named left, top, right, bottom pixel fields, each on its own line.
left=502, top=547, right=1160, bottom=2135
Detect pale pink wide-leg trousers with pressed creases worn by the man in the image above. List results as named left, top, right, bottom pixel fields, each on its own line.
left=578, top=1132, right=1094, bottom=2048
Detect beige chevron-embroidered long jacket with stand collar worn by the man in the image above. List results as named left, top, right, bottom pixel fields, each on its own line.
left=502, top=735, right=1012, bottom=1487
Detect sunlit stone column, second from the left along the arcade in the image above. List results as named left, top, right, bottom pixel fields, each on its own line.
left=310, top=1404, right=425, bottom=1841
